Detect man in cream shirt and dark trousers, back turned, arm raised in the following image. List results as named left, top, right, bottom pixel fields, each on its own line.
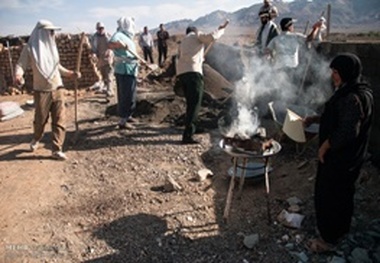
left=176, top=24, right=227, bottom=144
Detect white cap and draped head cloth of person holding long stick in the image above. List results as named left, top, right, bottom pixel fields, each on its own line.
left=28, top=20, right=61, bottom=80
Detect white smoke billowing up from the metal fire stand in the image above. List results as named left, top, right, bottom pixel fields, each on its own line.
left=217, top=42, right=331, bottom=138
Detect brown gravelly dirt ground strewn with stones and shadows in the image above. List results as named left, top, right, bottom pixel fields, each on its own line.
left=0, top=33, right=380, bottom=263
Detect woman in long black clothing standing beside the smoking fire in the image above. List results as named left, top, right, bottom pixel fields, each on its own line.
left=304, top=53, right=374, bottom=252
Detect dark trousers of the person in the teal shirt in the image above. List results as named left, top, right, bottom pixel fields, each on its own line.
left=115, top=74, right=137, bottom=119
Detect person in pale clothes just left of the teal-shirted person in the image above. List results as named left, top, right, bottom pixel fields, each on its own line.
left=91, top=22, right=114, bottom=97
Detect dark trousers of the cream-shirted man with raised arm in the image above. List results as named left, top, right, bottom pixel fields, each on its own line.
left=178, top=72, right=204, bottom=139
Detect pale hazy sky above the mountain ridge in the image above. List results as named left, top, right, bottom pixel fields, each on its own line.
left=0, top=0, right=276, bottom=36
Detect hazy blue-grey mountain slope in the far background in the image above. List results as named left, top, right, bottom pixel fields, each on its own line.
left=165, top=0, right=380, bottom=33
